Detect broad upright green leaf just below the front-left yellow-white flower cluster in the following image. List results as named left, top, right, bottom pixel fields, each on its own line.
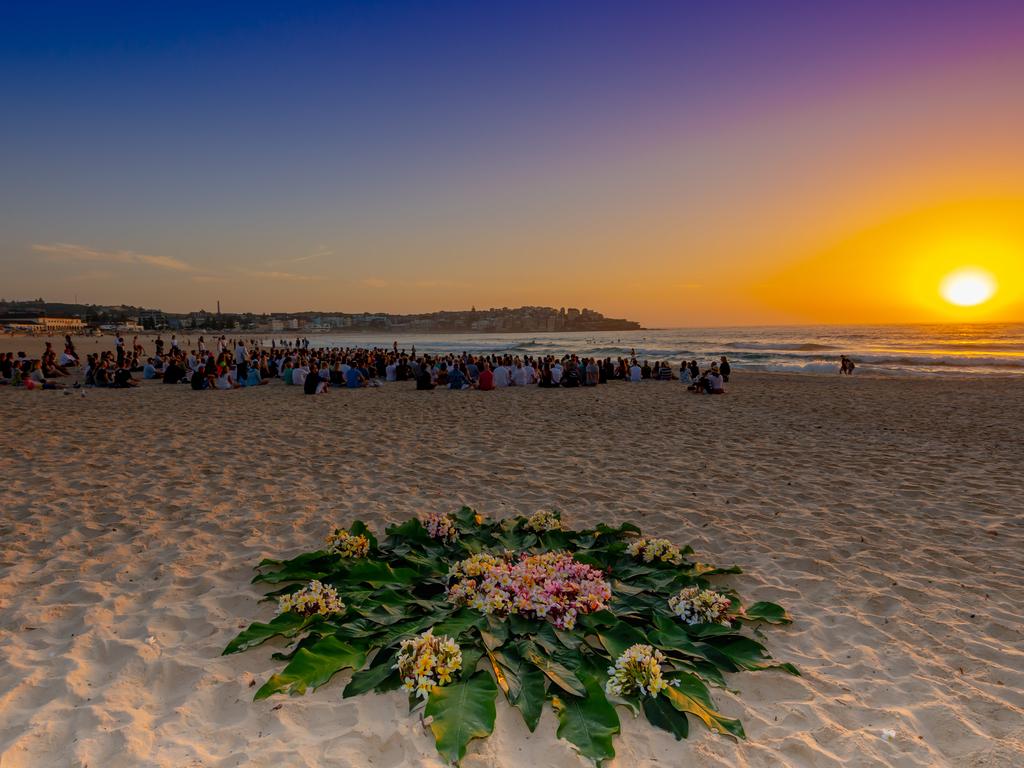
left=424, top=672, right=498, bottom=763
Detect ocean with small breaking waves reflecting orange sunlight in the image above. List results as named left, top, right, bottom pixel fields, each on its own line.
left=258, top=323, right=1024, bottom=376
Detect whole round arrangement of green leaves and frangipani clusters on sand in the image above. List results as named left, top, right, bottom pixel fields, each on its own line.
left=224, top=507, right=799, bottom=765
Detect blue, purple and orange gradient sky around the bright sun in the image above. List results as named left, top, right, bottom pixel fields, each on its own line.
left=0, top=0, right=1024, bottom=327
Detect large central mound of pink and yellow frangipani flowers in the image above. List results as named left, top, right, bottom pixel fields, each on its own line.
left=447, top=552, right=611, bottom=630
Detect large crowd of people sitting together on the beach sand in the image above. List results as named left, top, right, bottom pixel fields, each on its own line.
left=0, top=336, right=730, bottom=394
